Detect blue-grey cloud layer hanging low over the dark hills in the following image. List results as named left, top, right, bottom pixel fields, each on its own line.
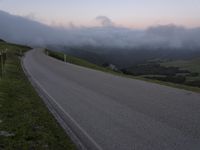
left=0, top=11, right=200, bottom=50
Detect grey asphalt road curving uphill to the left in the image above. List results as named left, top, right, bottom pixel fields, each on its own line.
left=23, top=50, right=200, bottom=150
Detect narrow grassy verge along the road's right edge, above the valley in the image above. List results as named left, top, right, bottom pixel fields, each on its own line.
left=46, top=50, right=200, bottom=93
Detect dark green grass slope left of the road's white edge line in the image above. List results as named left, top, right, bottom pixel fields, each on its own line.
left=0, top=42, right=76, bottom=150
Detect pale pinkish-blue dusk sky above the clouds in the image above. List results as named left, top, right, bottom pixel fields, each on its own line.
left=0, top=0, right=200, bottom=28
